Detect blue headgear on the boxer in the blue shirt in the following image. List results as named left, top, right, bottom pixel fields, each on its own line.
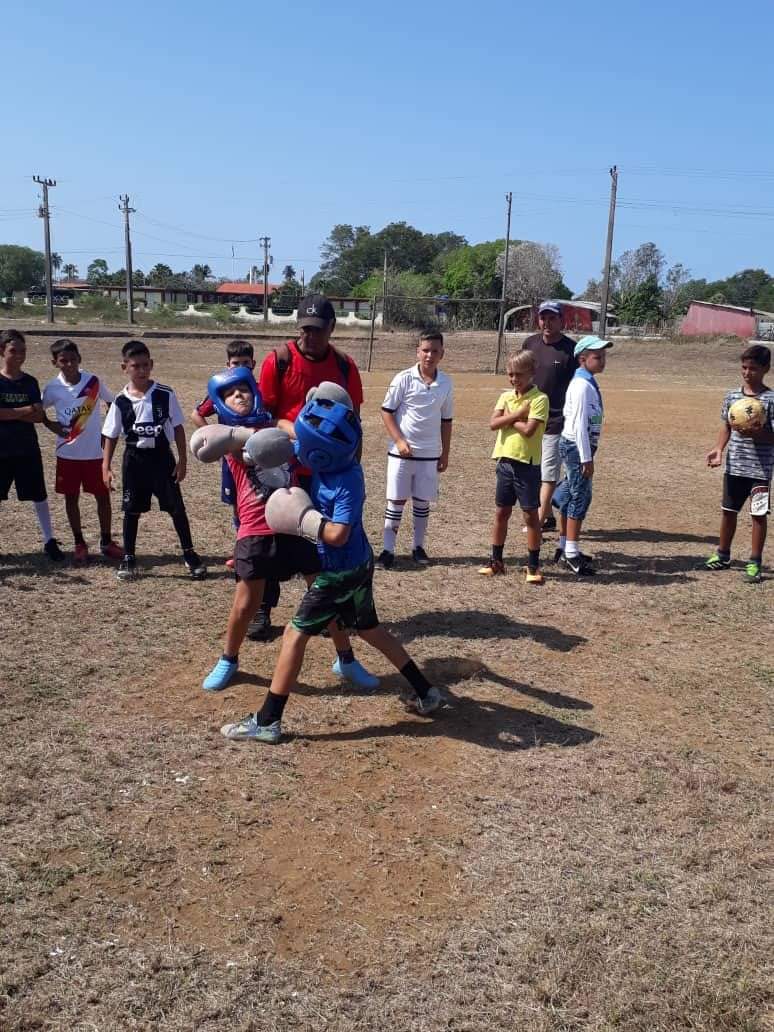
left=295, top=397, right=362, bottom=473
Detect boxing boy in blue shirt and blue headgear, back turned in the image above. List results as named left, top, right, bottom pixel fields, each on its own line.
left=221, top=383, right=443, bottom=743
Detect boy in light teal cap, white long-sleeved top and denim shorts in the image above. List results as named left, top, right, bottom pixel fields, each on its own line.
left=553, top=335, right=613, bottom=577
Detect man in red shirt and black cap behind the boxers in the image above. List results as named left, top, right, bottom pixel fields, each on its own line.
left=254, top=294, right=363, bottom=639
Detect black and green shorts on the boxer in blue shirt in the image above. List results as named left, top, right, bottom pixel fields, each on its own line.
left=291, top=559, right=379, bottom=636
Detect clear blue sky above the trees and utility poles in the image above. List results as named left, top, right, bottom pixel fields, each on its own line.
left=0, top=0, right=774, bottom=290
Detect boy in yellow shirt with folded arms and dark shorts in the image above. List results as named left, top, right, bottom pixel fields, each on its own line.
left=479, top=351, right=548, bottom=584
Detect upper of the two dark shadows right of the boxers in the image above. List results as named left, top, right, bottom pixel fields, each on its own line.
left=389, top=609, right=588, bottom=652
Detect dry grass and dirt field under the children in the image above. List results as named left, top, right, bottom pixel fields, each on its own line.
left=0, top=333, right=774, bottom=1032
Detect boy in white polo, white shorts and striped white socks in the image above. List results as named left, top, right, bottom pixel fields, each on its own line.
left=377, top=330, right=454, bottom=570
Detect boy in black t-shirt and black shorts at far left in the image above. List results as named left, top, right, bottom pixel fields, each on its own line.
left=0, top=329, right=64, bottom=562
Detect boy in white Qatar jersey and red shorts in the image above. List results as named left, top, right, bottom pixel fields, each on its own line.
left=42, top=337, right=124, bottom=562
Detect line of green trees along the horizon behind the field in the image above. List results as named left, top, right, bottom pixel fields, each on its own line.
left=0, top=230, right=774, bottom=325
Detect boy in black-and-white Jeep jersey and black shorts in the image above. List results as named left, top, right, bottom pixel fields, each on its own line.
left=102, top=341, right=206, bottom=580
